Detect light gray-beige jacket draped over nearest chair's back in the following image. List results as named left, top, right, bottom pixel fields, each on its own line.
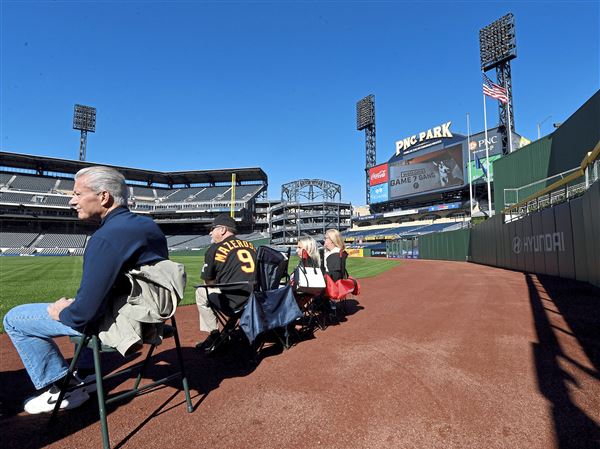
left=98, top=260, right=186, bottom=356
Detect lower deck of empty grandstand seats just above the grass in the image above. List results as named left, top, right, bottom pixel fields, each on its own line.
left=0, top=232, right=266, bottom=256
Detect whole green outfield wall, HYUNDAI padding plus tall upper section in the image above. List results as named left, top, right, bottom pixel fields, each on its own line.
left=419, top=91, right=600, bottom=287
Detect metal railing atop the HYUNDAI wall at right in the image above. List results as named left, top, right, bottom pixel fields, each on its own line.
left=502, top=141, right=600, bottom=222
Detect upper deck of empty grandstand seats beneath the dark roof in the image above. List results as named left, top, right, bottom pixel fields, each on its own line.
left=0, top=173, right=262, bottom=207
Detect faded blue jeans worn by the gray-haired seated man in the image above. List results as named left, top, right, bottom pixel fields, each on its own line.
left=4, top=303, right=91, bottom=390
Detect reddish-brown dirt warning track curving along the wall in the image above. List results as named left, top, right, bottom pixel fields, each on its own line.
left=0, top=260, right=600, bottom=449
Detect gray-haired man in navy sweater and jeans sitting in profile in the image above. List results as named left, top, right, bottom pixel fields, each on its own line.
left=4, top=166, right=169, bottom=414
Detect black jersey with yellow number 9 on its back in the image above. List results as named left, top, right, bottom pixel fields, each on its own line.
left=200, top=235, right=256, bottom=299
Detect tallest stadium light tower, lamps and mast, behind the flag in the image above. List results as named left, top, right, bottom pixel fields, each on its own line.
left=479, top=13, right=517, bottom=154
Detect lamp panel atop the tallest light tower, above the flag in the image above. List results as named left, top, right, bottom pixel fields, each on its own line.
left=479, top=13, right=517, bottom=72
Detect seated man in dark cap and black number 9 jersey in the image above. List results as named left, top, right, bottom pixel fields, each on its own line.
left=196, top=214, right=256, bottom=352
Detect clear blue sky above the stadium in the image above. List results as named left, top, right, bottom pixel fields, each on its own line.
left=0, top=0, right=600, bottom=205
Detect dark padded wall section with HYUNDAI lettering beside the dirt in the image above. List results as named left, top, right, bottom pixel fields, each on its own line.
left=469, top=182, right=600, bottom=287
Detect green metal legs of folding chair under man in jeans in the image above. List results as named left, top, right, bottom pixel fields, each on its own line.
left=50, top=316, right=194, bottom=449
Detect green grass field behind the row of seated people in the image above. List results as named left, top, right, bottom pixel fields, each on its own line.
left=0, top=255, right=400, bottom=332
